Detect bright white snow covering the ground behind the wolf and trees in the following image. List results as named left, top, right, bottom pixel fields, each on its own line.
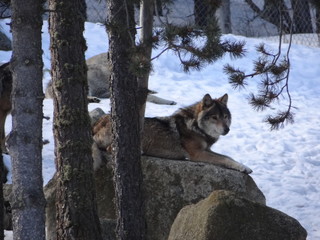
left=0, top=22, right=320, bottom=240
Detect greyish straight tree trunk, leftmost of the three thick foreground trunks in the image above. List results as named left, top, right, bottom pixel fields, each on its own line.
left=8, top=0, right=45, bottom=240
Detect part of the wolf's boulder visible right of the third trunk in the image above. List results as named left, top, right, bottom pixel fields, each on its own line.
left=142, top=157, right=266, bottom=240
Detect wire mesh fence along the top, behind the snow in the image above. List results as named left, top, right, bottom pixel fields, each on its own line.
left=86, top=0, right=320, bottom=47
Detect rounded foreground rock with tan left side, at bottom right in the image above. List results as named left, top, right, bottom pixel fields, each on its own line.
left=168, top=190, right=307, bottom=240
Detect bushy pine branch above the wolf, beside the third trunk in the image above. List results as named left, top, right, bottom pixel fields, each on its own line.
left=152, top=12, right=245, bottom=72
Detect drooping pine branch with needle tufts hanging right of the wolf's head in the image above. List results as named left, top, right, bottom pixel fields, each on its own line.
left=224, top=37, right=293, bottom=130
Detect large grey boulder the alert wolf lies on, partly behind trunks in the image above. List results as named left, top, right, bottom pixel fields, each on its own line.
left=45, top=156, right=265, bottom=240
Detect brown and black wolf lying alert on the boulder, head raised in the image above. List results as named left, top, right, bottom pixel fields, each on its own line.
left=92, top=94, right=252, bottom=174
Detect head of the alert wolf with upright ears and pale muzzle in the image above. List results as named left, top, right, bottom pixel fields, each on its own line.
left=197, top=94, right=231, bottom=138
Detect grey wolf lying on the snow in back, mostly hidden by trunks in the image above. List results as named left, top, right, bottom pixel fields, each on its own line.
left=45, top=53, right=176, bottom=105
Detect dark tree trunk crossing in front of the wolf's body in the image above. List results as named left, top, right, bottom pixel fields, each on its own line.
left=107, top=0, right=145, bottom=240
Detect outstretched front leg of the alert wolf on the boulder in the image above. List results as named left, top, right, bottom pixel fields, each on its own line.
left=190, top=151, right=252, bottom=174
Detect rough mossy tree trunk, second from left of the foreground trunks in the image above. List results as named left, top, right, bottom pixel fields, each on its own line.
left=49, top=0, right=102, bottom=240
